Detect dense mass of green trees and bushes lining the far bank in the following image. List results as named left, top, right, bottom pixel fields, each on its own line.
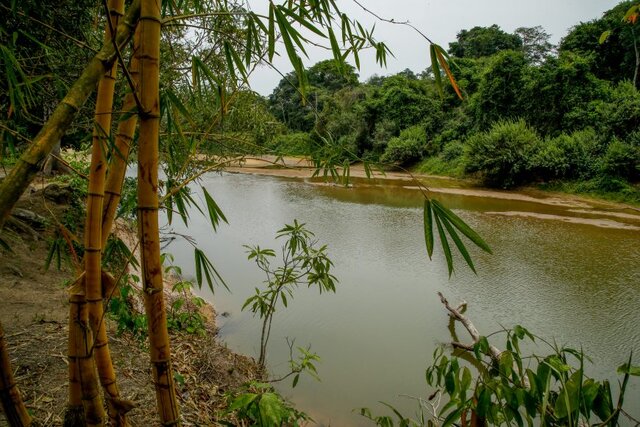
left=269, top=1, right=640, bottom=202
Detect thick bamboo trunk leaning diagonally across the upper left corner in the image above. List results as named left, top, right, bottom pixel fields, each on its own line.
left=0, top=0, right=140, bottom=234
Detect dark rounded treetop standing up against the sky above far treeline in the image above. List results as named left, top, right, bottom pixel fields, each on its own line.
left=449, top=24, right=523, bottom=58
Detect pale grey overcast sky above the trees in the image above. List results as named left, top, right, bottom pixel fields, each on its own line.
left=249, top=0, right=619, bottom=95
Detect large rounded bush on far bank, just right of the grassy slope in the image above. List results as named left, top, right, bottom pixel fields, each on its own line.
left=465, top=120, right=541, bottom=188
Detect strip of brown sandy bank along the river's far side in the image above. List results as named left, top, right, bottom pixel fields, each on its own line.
left=225, top=156, right=640, bottom=230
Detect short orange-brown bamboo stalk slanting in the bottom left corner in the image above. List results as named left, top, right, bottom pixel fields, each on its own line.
left=0, top=323, right=31, bottom=427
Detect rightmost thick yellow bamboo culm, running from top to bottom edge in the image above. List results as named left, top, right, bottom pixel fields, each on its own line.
left=138, top=0, right=181, bottom=426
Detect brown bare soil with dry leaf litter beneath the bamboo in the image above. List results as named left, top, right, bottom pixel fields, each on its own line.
left=0, top=176, right=258, bottom=426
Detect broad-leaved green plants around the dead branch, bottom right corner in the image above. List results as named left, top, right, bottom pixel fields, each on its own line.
left=360, top=325, right=640, bottom=427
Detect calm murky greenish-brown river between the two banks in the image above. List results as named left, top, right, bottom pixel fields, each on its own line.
left=165, top=174, right=640, bottom=426
